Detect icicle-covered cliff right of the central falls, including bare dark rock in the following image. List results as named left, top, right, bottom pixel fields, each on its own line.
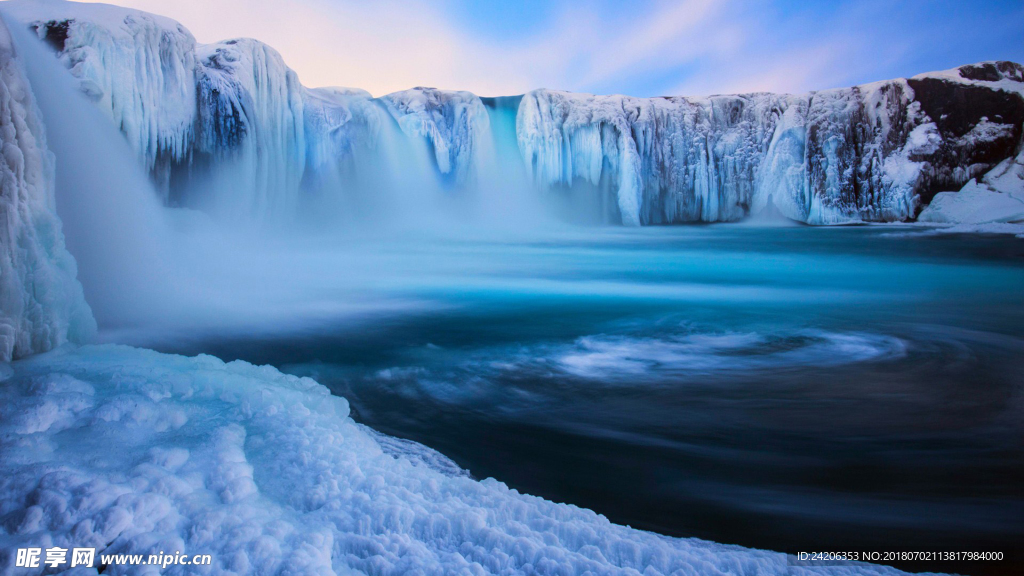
left=518, top=67, right=1024, bottom=224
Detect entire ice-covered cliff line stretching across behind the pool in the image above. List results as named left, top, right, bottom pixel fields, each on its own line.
left=6, top=0, right=1024, bottom=224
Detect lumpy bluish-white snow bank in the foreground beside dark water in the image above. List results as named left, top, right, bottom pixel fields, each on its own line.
left=0, top=345, right=925, bottom=575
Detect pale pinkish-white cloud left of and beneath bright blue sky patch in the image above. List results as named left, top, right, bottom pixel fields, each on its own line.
left=74, top=0, right=745, bottom=95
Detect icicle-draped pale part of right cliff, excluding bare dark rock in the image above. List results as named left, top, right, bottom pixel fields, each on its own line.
left=517, top=81, right=942, bottom=224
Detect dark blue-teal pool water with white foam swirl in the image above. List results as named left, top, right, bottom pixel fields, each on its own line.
left=151, top=225, right=1024, bottom=574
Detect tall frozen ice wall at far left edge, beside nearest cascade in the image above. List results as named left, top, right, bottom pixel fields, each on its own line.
left=0, top=15, right=95, bottom=362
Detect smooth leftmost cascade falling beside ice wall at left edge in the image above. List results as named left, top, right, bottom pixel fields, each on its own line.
left=8, top=12, right=180, bottom=325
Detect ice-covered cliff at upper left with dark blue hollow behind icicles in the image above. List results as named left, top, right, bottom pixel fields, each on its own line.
left=6, top=2, right=304, bottom=216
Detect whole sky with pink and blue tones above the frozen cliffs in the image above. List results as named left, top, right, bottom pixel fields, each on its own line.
left=86, top=0, right=1024, bottom=96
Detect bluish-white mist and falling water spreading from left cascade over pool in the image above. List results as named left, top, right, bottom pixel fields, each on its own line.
left=4, top=14, right=571, bottom=344
